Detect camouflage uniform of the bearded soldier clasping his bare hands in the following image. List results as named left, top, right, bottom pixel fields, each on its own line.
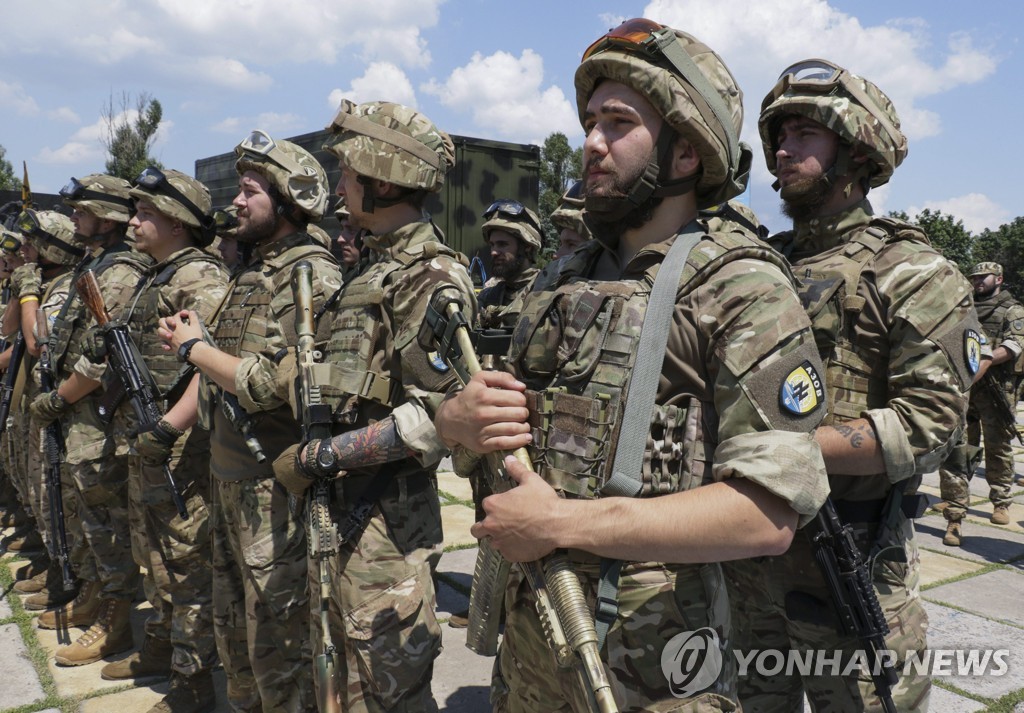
left=209, top=233, right=341, bottom=712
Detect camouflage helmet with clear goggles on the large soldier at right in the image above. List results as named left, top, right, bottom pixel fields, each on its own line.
left=758, top=59, right=907, bottom=187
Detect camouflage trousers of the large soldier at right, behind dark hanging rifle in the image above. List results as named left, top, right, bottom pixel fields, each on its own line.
left=723, top=518, right=931, bottom=713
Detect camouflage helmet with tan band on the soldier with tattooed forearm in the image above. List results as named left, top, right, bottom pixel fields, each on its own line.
left=324, top=100, right=455, bottom=193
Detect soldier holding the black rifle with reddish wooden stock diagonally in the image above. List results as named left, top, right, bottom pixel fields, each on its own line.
left=100, top=167, right=227, bottom=713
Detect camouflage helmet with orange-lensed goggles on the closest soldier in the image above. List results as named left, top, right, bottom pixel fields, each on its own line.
left=575, top=18, right=753, bottom=208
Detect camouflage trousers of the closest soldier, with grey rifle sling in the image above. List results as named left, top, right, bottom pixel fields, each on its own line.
left=490, top=554, right=738, bottom=713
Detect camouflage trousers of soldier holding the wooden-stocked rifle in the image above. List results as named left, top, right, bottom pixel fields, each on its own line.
left=128, top=437, right=217, bottom=676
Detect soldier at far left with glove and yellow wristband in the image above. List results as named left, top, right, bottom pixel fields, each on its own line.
left=4, top=214, right=85, bottom=593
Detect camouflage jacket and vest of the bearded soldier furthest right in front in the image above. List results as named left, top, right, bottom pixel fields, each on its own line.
left=771, top=200, right=981, bottom=500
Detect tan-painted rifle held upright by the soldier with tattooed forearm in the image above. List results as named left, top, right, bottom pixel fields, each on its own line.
left=292, top=260, right=341, bottom=713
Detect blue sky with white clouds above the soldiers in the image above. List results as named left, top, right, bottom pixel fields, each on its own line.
left=0, top=0, right=1024, bottom=239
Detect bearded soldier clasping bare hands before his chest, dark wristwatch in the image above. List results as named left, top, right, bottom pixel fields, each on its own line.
left=159, top=131, right=341, bottom=713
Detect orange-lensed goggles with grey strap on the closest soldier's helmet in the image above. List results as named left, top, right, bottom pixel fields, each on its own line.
left=583, top=17, right=739, bottom=171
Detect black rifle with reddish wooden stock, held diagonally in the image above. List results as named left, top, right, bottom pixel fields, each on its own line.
left=75, top=269, right=188, bottom=519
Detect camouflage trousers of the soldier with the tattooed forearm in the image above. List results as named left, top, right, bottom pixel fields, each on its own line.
left=309, top=481, right=441, bottom=713
